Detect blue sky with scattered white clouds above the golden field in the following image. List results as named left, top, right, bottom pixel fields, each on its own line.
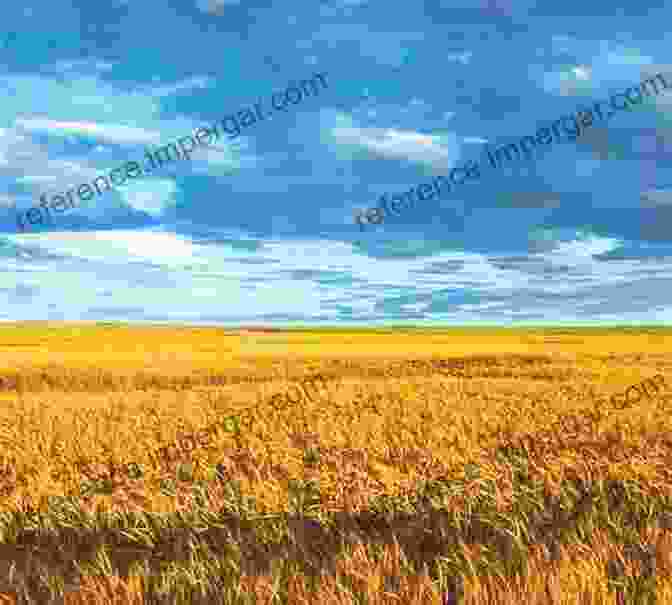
left=0, top=0, right=672, bottom=325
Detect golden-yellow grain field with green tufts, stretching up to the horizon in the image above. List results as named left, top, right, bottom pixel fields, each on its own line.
left=0, top=323, right=672, bottom=605
